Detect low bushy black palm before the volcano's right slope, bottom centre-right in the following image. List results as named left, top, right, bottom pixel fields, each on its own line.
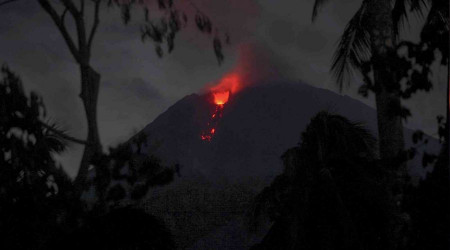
left=251, top=112, right=390, bottom=249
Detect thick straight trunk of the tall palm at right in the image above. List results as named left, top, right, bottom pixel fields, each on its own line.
left=370, top=0, right=404, bottom=159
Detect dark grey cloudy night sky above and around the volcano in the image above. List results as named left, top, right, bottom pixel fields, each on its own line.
left=0, top=0, right=447, bottom=176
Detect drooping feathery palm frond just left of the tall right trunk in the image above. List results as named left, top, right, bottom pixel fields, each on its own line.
left=331, top=0, right=371, bottom=90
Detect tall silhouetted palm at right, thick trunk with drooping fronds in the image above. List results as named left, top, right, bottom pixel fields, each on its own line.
left=312, top=0, right=431, bottom=159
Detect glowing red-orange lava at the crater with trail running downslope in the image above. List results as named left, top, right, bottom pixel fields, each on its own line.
left=200, top=74, right=241, bottom=141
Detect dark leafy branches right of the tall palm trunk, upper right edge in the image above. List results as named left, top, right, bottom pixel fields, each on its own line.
left=392, top=0, right=450, bottom=167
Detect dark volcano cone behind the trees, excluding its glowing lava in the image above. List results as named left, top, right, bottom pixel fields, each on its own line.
left=136, top=82, right=438, bottom=181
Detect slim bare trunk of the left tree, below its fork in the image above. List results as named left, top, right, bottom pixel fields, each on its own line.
left=75, top=65, right=102, bottom=194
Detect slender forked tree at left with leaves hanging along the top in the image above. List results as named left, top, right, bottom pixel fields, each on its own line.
left=0, top=0, right=229, bottom=194
